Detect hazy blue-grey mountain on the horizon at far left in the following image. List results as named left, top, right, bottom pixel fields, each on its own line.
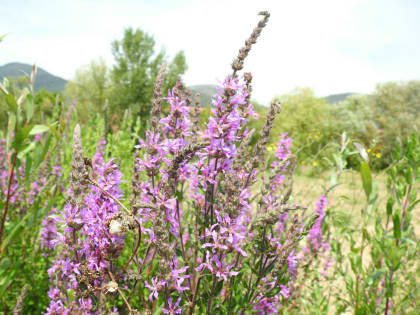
left=0, top=62, right=67, bottom=92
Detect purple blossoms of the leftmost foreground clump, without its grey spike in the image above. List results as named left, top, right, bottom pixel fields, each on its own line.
left=46, top=141, right=124, bottom=314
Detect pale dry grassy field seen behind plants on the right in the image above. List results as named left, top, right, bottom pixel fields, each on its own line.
left=293, top=169, right=420, bottom=314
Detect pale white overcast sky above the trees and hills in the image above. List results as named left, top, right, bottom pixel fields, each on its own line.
left=0, top=0, right=420, bottom=104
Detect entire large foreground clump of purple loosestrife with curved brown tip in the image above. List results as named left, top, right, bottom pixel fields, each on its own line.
left=45, top=12, right=327, bottom=314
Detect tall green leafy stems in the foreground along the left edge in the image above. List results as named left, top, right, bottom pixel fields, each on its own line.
left=0, top=67, right=64, bottom=314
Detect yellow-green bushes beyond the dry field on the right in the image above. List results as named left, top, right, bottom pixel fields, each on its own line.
left=273, top=81, right=420, bottom=169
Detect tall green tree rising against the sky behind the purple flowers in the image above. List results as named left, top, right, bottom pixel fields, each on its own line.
left=111, top=28, right=187, bottom=119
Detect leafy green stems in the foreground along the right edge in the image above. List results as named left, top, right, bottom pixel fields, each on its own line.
left=330, top=134, right=420, bottom=314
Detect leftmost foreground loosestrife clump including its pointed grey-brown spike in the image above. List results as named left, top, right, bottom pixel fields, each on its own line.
left=42, top=125, right=124, bottom=314
